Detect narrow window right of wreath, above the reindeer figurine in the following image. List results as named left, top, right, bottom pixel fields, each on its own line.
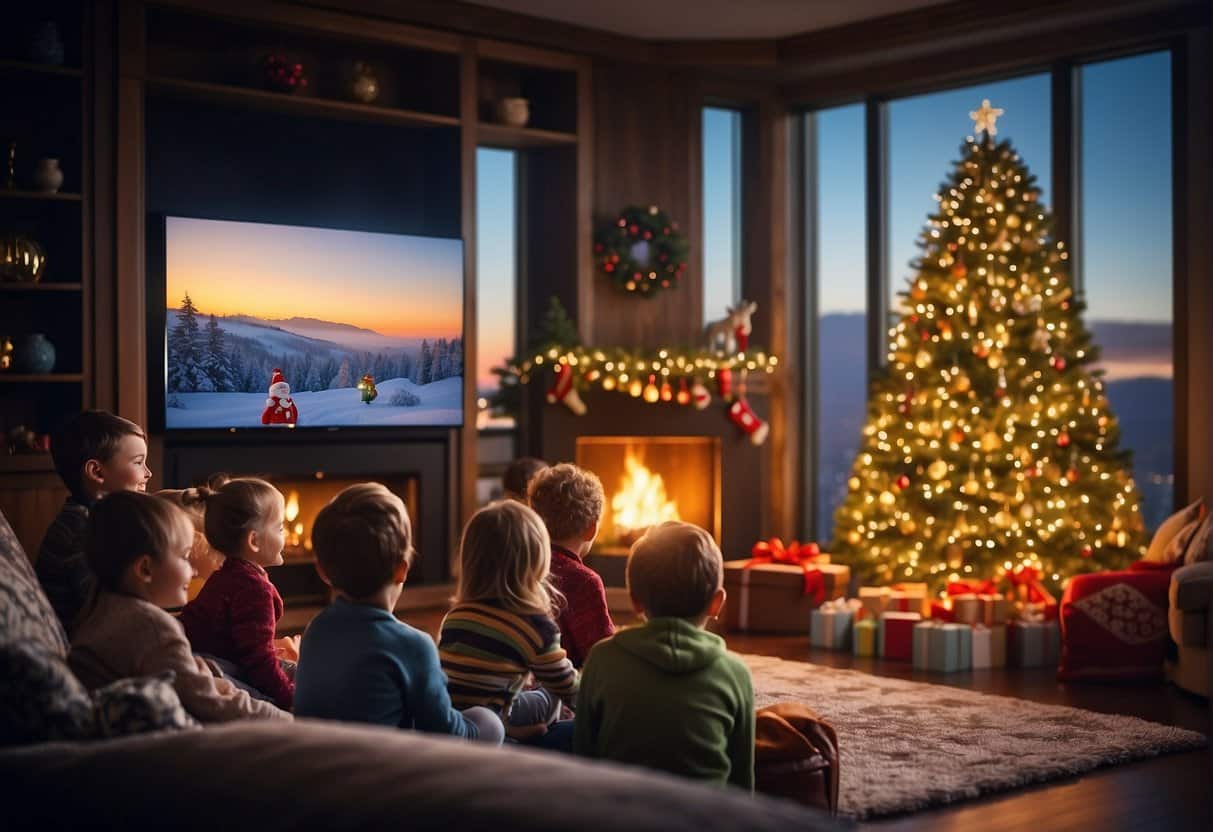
left=702, top=107, right=741, bottom=323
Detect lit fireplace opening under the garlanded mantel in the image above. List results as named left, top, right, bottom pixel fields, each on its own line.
left=576, top=437, right=721, bottom=586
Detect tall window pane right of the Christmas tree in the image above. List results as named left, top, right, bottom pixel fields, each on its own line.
left=1078, top=52, right=1175, bottom=529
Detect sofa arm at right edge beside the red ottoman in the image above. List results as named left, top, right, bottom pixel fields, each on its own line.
left=1167, top=560, right=1213, bottom=697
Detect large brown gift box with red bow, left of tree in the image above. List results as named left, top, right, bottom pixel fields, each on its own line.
left=723, top=560, right=850, bottom=633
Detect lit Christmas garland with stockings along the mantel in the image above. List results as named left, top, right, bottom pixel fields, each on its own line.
left=497, top=301, right=779, bottom=445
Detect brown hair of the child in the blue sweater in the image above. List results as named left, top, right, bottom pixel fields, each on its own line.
left=312, top=483, right=412, bottom=599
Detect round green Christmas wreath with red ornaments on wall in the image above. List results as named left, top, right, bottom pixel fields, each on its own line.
left=594, top=205, right=689, bottom=297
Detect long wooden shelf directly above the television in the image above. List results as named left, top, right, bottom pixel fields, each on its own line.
left=147, top=78, right=460, bottom=127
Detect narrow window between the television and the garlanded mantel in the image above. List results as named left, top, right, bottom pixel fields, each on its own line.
left=475, top=148, right=518, bottom=503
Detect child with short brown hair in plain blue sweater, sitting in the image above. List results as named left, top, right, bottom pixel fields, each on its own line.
left=295, top=483, right=502, bottom=743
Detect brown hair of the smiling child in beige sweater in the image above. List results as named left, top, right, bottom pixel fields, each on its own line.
left=85, top=491, right=194, bottom=592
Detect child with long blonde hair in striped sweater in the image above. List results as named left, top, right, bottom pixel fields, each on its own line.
left=438, top=500, right=577, bottom=746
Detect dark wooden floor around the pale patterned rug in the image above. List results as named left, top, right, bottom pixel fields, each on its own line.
left=368, top=610, right=1213, bottom=832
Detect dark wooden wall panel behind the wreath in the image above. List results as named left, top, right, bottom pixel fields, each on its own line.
left=582, top=62, right=702, bottom=347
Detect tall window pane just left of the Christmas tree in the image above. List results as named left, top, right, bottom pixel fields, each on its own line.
left=805, top=104, right=867, bottom=540
